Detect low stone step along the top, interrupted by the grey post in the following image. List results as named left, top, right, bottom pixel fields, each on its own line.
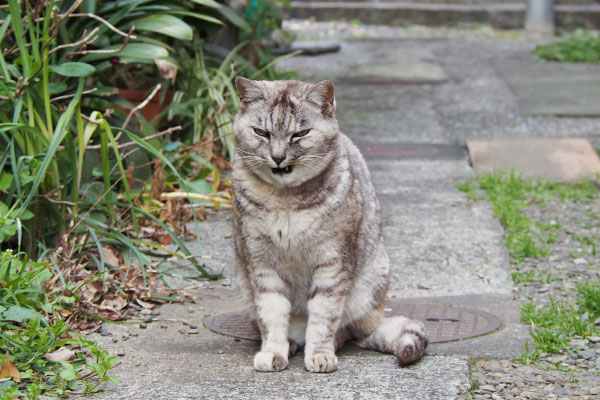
left=283, top=0, right=600, bottom=29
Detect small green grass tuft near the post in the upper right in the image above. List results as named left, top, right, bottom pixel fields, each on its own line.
left=533, top=29, right=600, bottom=63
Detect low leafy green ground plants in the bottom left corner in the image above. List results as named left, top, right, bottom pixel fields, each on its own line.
left=0, top=251, right=116, bottom=399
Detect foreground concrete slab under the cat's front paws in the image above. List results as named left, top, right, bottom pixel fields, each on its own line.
left=94, top=289, right=469, bottom=400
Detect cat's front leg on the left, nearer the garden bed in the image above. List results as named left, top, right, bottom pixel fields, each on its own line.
left=254, top=269, right=291, bottom=372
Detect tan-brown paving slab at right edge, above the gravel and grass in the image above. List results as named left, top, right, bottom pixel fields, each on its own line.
left=467, top=138, right=600, bottom=182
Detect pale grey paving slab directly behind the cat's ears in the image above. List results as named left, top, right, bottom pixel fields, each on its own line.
left=277, top=40, right=447, bottom=83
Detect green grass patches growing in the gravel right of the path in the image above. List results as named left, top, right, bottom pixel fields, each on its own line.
left=457, top=171, right=600, bottom=362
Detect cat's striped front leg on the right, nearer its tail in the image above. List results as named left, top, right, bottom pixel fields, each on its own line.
left=304, top=261, right=350, bottom=372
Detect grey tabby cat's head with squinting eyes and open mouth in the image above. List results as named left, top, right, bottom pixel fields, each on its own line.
left=234, top=77, right=338, bottom=187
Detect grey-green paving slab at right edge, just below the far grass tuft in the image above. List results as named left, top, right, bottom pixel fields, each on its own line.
left=497, top=57, right=600, bottom=117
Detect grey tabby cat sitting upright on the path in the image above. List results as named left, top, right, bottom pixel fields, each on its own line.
left=233, top=77, right=427, bottom=372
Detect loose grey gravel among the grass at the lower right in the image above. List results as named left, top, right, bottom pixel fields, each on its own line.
left=470, top=195, right=600, bottom=400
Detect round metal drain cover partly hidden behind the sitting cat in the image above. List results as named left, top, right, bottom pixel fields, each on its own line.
left=204, top=300, right=500, bottom=343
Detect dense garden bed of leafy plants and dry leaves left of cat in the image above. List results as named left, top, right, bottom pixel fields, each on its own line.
left=0, top=0, right=290, bottom=399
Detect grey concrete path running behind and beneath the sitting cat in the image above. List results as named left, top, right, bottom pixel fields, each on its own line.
left=95, top=35, right=600, bottom=400
